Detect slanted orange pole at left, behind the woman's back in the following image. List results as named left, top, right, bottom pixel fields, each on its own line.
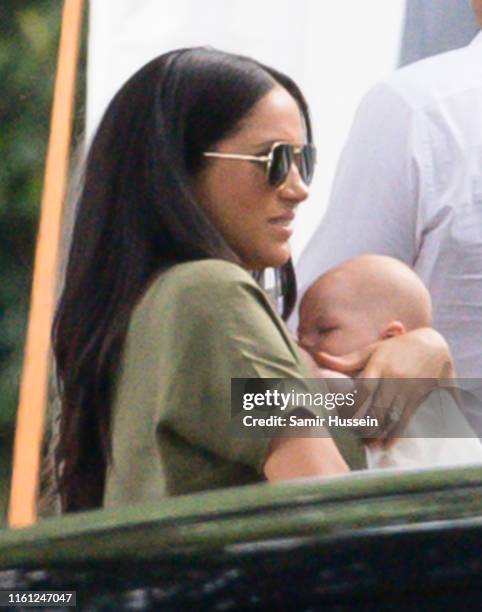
left=9, top=0, right=84, bottom=527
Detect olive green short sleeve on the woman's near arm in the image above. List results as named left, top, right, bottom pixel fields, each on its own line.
left=149, top=261, right=324, bottom=472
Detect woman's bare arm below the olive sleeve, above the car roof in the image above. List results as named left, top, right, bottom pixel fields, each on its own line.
left=264, top=438, right=350, bottom=482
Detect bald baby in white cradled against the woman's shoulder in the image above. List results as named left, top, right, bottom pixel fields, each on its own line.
left=298, top=255, right=482, bottom=468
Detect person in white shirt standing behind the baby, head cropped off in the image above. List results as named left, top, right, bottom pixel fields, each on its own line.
left=297, top=0, right=482, bottom=436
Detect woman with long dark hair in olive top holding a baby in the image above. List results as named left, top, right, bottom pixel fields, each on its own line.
left=54, top=48, right=456, bottom=511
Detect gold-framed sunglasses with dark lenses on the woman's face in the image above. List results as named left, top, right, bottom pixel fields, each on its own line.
left=203, top=142, right=316, bottom=187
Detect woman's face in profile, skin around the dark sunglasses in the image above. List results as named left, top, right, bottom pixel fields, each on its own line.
left=194, top=86, right=308, bottom=270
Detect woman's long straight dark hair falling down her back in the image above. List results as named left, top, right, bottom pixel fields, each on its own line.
left=53, top=48, right=311, bottom=512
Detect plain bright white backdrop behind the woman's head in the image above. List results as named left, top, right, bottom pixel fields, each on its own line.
left=87, top=0, right=405, bottom=259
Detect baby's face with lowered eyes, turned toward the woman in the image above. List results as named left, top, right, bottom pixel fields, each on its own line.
left=298, top=280, right=379, bottom=355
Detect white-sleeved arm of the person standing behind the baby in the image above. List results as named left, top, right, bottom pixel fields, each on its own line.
left=297, top=84, right=420, bottom=326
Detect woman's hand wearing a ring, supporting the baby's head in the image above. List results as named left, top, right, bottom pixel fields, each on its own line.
left=316, top=328, right=455, bottom=444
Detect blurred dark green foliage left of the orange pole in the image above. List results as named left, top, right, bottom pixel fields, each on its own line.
left=0, top=0, right=83, bottom=520
